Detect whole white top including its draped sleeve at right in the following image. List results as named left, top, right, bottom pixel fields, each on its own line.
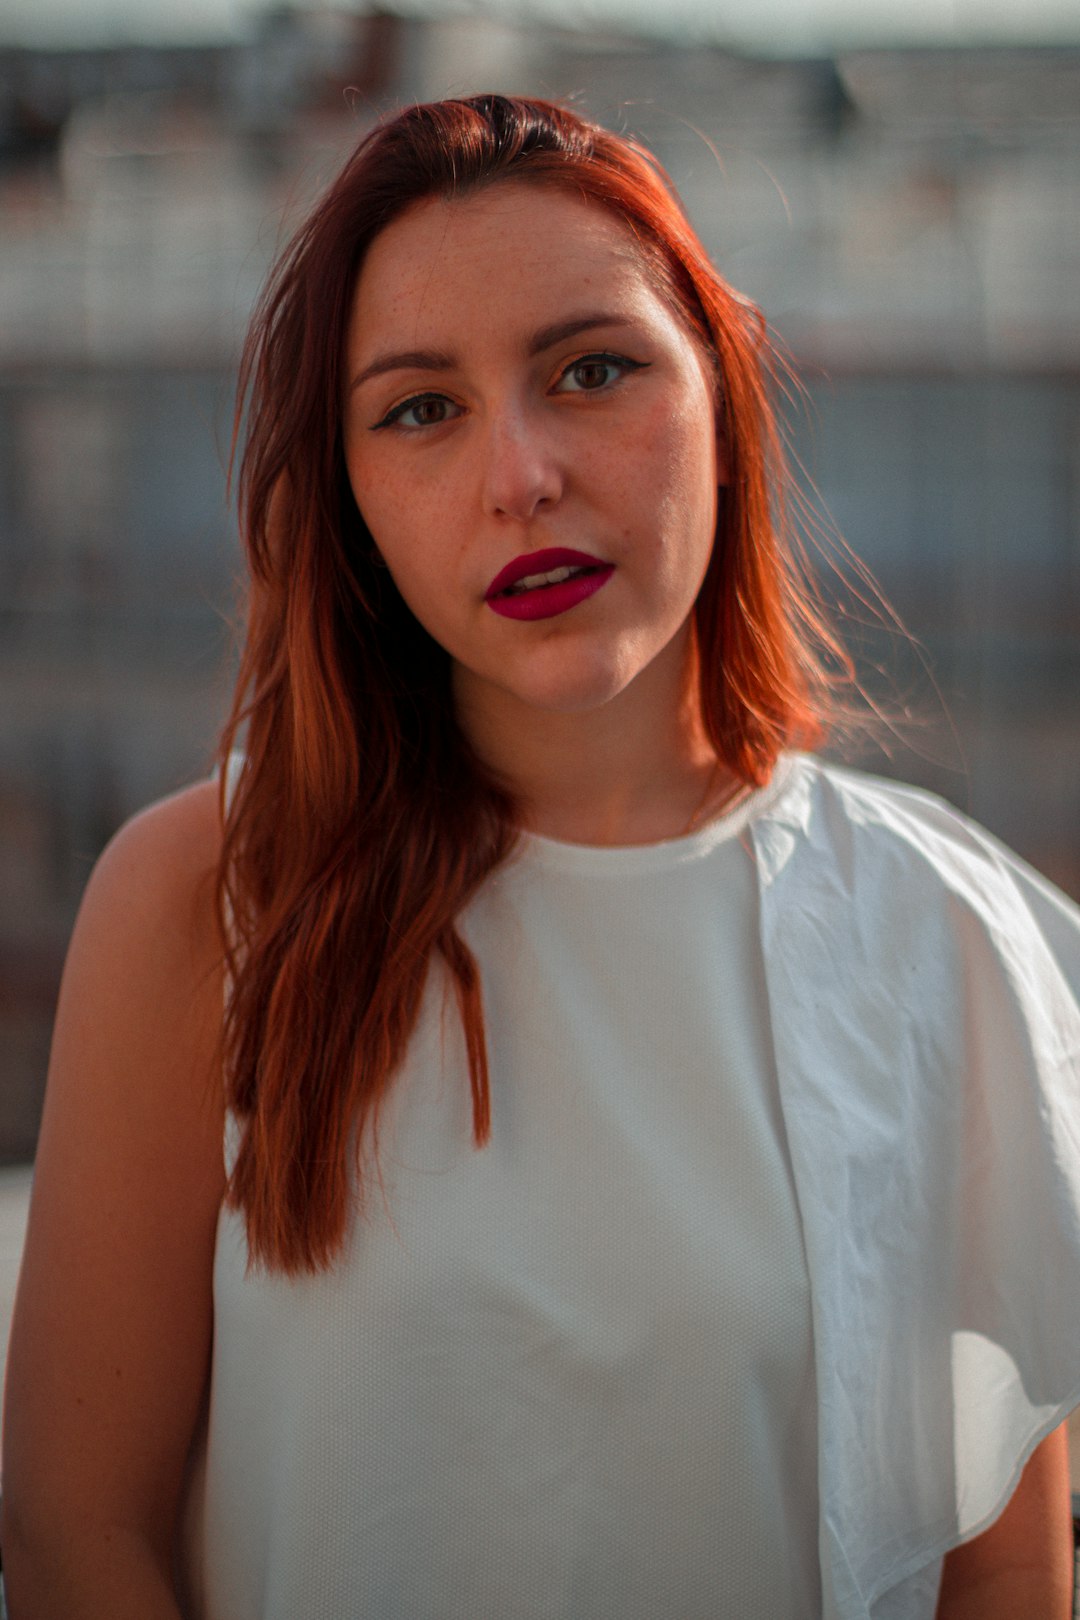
left=181, top=757, right=1080, bottom=1620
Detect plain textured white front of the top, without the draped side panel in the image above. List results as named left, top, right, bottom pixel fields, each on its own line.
left=179, top=773, right=821, bottom=1620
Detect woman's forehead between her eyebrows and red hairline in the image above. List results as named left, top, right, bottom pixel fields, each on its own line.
left=351, top=181, right=667, bottom=342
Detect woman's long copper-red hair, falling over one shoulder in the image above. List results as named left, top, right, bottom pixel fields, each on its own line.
left=219, top=96, right=850, bottom=1273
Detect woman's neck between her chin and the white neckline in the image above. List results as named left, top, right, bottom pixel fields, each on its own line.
left=455, top=625, right=737, bottom=846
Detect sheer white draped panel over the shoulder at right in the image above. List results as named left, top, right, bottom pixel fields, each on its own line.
left=751, top=758, right=1080, bottom=1620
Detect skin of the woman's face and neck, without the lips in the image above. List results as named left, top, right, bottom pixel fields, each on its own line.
left=345, top=183, right=744, bottom=844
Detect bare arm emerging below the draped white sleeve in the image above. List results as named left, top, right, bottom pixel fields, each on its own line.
left=938, top=1424, right=1074, bottom=1620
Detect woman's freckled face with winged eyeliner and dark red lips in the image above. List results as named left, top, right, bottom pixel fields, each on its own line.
left=345, top=181, right=724, bottom=719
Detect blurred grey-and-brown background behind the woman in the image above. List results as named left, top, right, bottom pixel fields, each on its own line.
left=0, top=0, right=1080, bottom=1165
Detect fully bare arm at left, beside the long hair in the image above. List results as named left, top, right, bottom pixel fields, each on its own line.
left=0, top=784, right=223, bottom=1620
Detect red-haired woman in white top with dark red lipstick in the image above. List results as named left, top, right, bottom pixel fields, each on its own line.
left=3, top=97, right=1080, bottom=1620
